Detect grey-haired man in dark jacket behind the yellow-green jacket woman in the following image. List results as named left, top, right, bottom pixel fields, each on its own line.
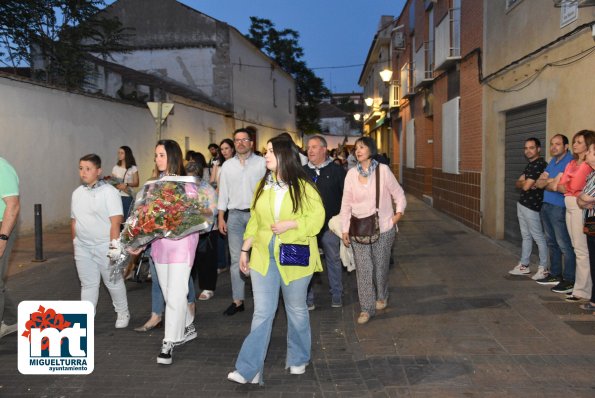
left=304, top=135, right=346, bottom=310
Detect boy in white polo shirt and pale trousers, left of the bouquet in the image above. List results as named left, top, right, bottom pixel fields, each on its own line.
left=70, top=154, right=130, bottom=328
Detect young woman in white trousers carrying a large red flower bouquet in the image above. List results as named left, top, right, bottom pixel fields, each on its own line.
left=130, top=140, right=217, bottom=365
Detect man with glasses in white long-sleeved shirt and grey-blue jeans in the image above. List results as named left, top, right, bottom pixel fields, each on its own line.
left=217, top=127, right=266, bottom=315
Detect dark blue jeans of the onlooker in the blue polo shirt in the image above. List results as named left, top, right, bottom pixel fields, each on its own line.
left=541, top=203, right=576, bottom=282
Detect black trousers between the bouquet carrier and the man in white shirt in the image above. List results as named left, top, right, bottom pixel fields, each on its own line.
left=191, top=230, right=219, bottom=291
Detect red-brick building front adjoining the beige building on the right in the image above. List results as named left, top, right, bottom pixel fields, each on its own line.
left=392, top=0, right=483, bottom=230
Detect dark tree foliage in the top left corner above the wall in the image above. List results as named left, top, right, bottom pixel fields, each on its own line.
left=0, top=0, right=130, bottom=88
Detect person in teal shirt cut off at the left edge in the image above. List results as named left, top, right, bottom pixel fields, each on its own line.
left=0, top=158, right=21, bottom=338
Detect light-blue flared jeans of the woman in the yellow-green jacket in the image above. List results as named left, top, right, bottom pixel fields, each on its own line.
left=236, top=237, right=312, bottom=380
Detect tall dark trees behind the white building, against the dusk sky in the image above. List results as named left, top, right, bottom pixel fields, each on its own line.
left=248, top=17, right=330, bottom=134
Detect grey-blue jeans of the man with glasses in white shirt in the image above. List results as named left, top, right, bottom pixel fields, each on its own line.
left=227, top=210, right=250, bottom=301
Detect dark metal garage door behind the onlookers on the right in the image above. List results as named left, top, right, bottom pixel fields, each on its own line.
left=504, top=101, right=549, bottom=246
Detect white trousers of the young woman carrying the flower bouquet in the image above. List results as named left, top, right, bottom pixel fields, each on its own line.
left=155, top=262, right=194, bottom=343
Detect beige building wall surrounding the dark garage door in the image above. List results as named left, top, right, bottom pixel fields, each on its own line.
left=481, top=0, right=595, bottom=239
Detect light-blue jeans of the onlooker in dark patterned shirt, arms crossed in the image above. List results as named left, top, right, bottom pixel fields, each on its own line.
left=516, top=202, right=547, bottom=269
